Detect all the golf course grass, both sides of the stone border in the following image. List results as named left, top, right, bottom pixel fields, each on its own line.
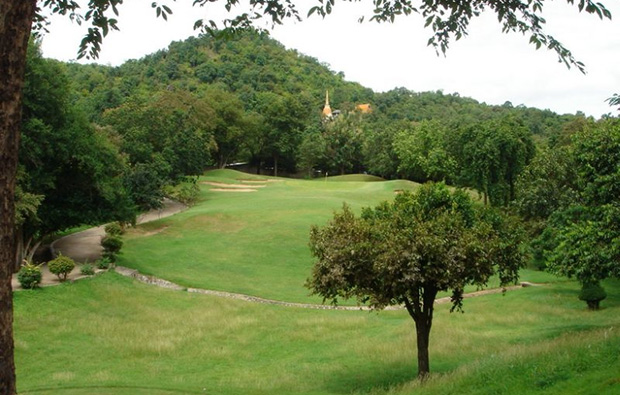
left=14, top=170, right=620, bottom=395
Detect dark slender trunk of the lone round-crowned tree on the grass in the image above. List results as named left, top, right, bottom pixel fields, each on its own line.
left=405, top=286, right=437, bottom=380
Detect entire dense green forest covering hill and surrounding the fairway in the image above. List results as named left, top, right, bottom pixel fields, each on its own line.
left=17, top=31, right=620, bottom=300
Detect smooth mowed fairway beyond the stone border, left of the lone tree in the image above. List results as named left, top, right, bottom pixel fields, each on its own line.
left=119, top=170, right=417, bottom=302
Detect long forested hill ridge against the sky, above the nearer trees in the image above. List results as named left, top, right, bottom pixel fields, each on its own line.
left=68, top=31, right=574, bottom=136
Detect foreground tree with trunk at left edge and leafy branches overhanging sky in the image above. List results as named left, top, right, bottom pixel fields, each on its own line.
left=0, top=0, right=611, bottom=394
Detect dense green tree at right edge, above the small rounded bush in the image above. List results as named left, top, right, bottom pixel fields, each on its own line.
left=544, top=119, right=620, bottom=285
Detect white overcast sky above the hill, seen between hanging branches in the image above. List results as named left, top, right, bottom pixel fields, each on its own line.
left=43, top=0, right=620, bottom=118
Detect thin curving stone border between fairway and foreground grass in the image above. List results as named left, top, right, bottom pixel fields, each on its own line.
left=116, top=266, right=540, bottom=311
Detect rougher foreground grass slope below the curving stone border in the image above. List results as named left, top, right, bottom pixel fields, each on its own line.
left=15, top=273, right=620, bottom=394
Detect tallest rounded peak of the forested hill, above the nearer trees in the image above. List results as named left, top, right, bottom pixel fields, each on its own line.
left=69, top=31, right=374, bottom=119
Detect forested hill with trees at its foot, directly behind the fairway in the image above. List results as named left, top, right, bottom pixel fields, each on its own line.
left=57, top=31, right=583, bottom=187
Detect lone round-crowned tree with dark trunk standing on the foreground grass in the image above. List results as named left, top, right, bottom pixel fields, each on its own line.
left=307, top=184, right=525, bottom=378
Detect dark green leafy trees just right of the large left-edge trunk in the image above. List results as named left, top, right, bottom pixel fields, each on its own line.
left=17, top=42, right=135, bottom=270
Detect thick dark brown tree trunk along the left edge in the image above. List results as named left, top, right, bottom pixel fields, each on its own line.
left=0, top=0, right=36, bottom=394
